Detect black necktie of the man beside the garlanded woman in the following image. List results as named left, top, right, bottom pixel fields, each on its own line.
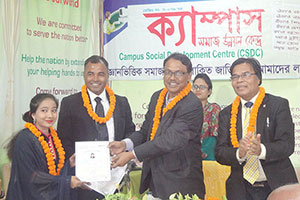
left=95, top=97, right=108, bottom=141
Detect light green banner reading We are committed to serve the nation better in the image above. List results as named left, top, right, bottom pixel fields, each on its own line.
left=15, top=0, right=99, bottom=124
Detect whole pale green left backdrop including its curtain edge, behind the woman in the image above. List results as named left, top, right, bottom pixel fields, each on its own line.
left=0, top=0, right=100, bottom=180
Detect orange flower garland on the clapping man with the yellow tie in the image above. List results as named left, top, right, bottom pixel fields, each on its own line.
left=230, top=87, right=265, bottom=148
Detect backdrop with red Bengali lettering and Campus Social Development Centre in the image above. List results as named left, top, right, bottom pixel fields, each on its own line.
left=103, top=0, right=300, bottom=167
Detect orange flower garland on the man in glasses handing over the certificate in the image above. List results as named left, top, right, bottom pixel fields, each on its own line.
left=150, top=83, right=192, bottom=140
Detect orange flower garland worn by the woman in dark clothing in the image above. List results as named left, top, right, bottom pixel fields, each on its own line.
left=24, top=123, right=65, bottom=176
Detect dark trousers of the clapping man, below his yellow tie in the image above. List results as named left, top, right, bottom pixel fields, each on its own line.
left=244, top=180, right=272, bottom=200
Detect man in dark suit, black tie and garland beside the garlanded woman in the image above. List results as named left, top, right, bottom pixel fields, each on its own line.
left=57, top=56, right=135, bottom=200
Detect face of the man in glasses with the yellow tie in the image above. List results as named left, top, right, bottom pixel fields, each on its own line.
left=232, top=63, right=260, bottom=101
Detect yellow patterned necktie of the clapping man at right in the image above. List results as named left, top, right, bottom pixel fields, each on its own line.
left=243, top=102, right=259, bottom=184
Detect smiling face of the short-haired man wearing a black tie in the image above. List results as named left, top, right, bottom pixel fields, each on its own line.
left=84, top=62, right=108, bottom=95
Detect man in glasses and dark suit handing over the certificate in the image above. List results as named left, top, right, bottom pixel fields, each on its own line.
left=110, top=53, right=205, bottom=199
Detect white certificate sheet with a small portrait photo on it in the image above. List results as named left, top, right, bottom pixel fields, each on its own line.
left=75, top=141, right=111, bottom=182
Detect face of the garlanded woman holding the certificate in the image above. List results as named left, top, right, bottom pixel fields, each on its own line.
left=32, top=98, right=57, bottom=134
